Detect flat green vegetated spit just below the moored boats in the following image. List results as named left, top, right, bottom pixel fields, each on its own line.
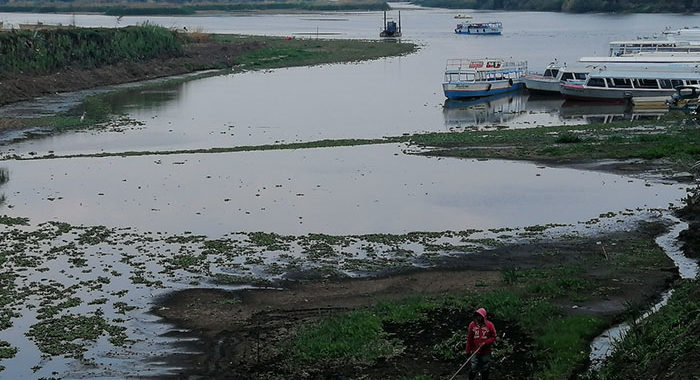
left=410, top=114, right=700, bottom=170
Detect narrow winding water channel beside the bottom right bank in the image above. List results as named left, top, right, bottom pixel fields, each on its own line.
left=590, top=212, right=698, bottom=369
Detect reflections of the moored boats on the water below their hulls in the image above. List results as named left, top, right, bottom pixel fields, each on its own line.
left=442, top=91, right=667, bottom=130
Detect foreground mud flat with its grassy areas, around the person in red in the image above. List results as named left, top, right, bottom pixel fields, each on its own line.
left=153, top=222, right=677, bottom=379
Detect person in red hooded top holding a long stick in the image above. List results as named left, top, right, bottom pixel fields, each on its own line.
left=467, top=308, right=496, bottom=380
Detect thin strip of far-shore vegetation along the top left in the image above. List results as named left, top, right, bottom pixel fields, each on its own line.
left=0, top=0, right=389, bottom=16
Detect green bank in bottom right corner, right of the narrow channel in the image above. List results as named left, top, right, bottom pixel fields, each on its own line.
left=590, top=279, right=700, bottom=380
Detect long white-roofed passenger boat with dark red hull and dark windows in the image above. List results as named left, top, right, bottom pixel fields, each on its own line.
left=560, top=65, right=700, bottom=102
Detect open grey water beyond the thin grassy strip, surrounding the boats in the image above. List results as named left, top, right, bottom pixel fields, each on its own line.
left=0, top=8, right=691, bottom=153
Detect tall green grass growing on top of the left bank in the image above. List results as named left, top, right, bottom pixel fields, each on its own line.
left=0, top=24, right=182, bottom=77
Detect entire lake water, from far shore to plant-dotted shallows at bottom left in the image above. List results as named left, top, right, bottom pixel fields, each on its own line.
left=0, top=4, right=694, bottom=378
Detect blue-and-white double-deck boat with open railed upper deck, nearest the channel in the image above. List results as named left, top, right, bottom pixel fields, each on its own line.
left=442, top=58, right=527, bottom=99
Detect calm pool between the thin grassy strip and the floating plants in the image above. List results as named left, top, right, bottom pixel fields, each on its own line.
left=0, top=144, right=685, bottom=236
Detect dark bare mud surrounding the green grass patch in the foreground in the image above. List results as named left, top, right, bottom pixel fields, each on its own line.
left=153, top=221, right=677, bottom=379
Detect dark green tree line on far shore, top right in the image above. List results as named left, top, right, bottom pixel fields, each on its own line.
left=414, top=0, right=700, bottom=13
